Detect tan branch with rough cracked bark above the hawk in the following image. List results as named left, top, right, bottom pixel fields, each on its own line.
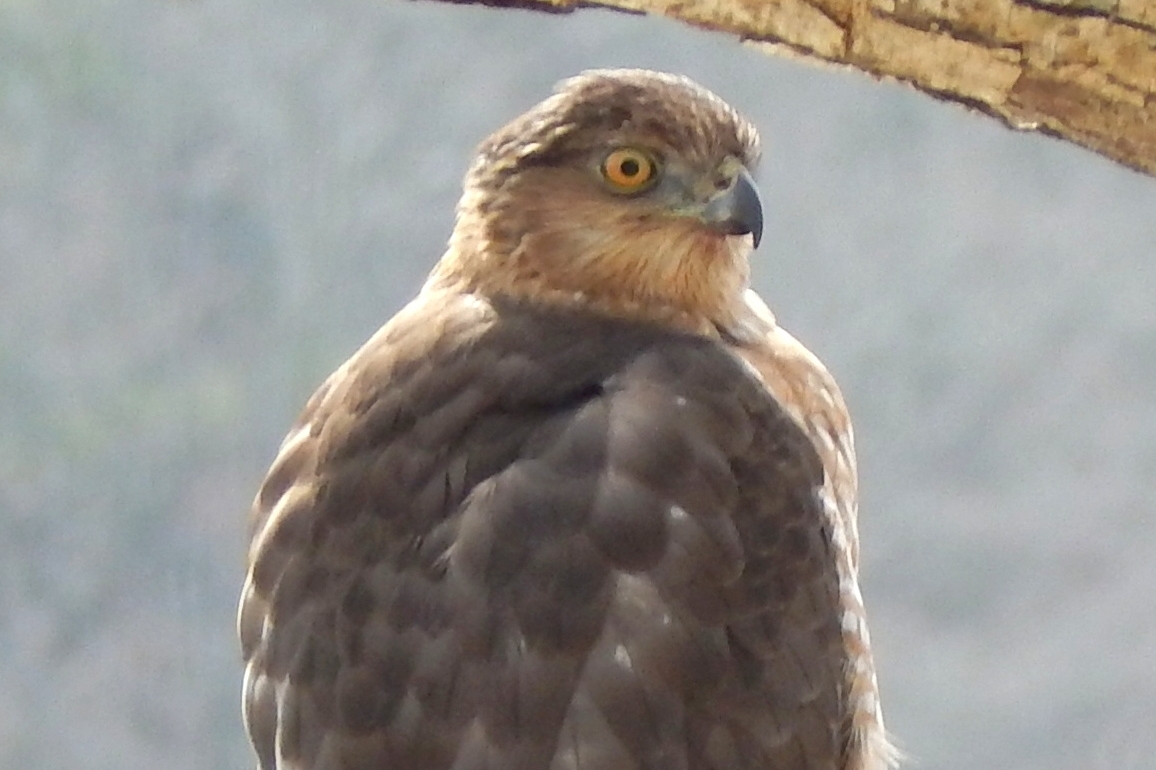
left=434, top=0, right=1156, bottom=176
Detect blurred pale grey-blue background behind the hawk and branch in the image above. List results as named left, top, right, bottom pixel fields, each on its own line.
left=0, top=0, right=1156, bottom=770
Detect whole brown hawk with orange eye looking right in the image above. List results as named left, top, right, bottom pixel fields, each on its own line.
left=238, top=71, right=894, bottom=770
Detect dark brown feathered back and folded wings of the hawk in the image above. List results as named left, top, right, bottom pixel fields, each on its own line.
left=239, top=295, right=850, bottom=770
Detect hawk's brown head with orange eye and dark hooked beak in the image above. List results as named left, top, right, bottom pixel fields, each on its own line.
left=434, top=69, right=763, bottom=330
